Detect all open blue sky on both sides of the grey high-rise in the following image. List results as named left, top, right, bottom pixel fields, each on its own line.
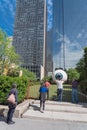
left=0, top=0, right=52, bottom=36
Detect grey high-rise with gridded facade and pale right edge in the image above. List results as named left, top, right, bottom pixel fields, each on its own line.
left=13, top=0, right=47, bottom=77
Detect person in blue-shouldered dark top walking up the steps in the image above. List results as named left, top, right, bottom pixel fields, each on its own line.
left=39, top=83, right=47, bottom=113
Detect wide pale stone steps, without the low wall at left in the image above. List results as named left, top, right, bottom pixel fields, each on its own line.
left=22, top=100, right=87, bottom=123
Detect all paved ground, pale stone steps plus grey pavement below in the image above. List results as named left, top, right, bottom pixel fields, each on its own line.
left=0, top=100, right=87, bottom=130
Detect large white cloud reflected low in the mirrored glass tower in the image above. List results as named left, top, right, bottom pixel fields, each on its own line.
left=53, top=31, right=83, bottom=69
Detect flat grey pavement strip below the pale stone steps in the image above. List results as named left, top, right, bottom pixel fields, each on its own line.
left=0, top=118, right=87, bottom=130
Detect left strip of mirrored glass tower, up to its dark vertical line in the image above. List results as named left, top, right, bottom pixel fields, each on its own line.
left=53, top=0, right=65, bottom=69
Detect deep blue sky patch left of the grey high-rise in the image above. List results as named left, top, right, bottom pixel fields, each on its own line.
left=0, top=0, right=16, bottom=36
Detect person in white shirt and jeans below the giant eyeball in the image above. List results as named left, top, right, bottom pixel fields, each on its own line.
left=55, top=79, right=64, bottom=102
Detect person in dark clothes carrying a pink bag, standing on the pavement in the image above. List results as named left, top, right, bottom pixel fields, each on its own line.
left=7, top=84, right=18, bottom=124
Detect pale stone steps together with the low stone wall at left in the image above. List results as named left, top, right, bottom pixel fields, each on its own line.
left=0, top=100, right=87, bottom=123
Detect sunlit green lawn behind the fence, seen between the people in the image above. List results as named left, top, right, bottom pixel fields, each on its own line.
left=29, top=84, right=87, bottom=102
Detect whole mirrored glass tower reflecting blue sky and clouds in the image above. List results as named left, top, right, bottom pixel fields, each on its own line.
left=53, top=0, right=87, bottom=69
